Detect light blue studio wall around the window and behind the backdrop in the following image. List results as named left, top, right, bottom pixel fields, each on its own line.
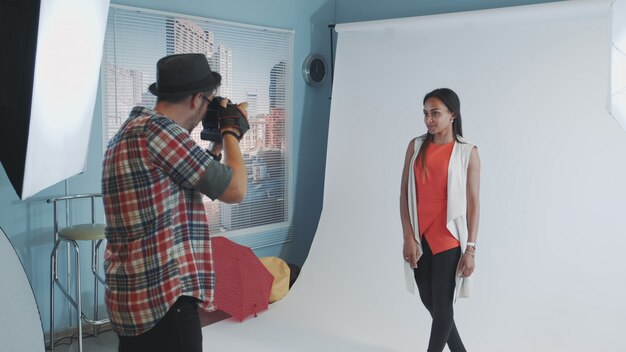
left=0, top=0, right=560, bottom=331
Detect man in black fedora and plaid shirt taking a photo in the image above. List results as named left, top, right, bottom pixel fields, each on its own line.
left=102, top=54, right=248, bottom=351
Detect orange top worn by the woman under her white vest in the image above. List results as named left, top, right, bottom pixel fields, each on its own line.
left=413, top=142, right=460, bottom=254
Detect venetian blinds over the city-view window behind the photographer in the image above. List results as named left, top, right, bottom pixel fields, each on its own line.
left=102, top=5, right=293, bottom=247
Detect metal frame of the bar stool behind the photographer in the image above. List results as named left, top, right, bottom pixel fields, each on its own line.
left=47, top=194, right=110, bottom=352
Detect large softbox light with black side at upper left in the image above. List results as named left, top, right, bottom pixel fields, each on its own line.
left=0, top=0, right=109, bottom=199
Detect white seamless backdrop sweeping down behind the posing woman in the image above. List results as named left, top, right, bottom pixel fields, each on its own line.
left=204, top=1, right=626, bottom=352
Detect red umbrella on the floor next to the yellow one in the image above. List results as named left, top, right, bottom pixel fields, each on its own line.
left=211, top=237, right=274, bottom=321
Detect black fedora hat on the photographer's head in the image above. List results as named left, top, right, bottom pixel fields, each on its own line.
left=148, top=54, right=222, bottom=97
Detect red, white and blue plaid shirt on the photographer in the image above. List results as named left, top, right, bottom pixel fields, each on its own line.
left=102, top=107, right=232, bottom=336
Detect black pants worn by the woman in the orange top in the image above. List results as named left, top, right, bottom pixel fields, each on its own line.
left=415, top=237, right=466, bottom=352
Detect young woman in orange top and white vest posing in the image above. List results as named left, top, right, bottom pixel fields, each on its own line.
left=400, top=88, right=480, bottom=352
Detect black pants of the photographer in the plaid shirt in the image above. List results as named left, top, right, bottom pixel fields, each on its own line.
left=118, top=296, right=202, bottom=352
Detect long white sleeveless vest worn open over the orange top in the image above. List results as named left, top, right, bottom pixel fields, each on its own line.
left=405, top=137, right=474, bottom=302
